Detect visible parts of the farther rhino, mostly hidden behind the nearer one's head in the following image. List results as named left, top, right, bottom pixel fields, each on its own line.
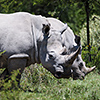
left=47, top=18, right=95, bottom=80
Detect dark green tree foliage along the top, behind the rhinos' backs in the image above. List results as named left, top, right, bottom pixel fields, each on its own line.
left=0, top=0, right=100, bottom=33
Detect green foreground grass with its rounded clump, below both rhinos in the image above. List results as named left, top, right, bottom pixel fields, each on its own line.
left=0, top=66, right=100, bottom=100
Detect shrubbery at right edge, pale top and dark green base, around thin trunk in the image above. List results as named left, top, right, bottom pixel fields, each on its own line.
left=79, top=15, right=100, bottom=71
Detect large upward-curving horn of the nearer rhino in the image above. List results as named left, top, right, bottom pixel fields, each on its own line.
left=65, top=47, right=81, bottom=66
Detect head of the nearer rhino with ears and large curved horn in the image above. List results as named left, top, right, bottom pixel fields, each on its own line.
left=40, top=24, right=80, bottom=78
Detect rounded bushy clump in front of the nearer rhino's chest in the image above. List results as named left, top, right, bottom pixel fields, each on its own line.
left=21, top=64, right=58, bottom=92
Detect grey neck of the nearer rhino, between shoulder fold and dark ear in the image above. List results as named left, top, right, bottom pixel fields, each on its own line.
left=31, top=15, right=49, bottom=63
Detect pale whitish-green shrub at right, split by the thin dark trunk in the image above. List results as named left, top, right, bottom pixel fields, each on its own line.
left=79, top=15, right=100, bottom=48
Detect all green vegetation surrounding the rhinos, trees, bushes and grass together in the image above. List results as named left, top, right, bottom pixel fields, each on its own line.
left=0, top=0, right=100, bottom=100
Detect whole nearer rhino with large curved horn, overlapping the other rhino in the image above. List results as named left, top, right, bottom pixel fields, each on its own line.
left=0, top=12, right=80, bottom=86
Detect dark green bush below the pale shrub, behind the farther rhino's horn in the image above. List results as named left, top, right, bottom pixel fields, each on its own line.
left=82, top=46, right=100, bottom=71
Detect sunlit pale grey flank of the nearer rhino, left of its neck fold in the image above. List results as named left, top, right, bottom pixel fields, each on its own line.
left=0, top=13, right=33, bottom=53
